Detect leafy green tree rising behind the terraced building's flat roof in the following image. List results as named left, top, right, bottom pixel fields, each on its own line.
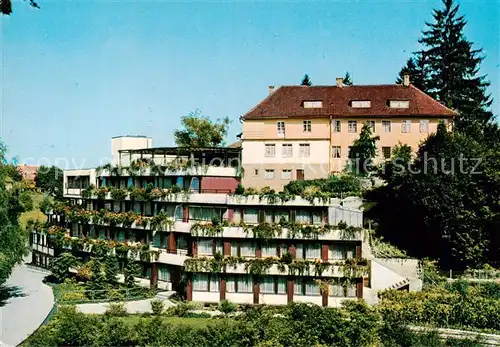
left=174, top=110, right=230, bottom=148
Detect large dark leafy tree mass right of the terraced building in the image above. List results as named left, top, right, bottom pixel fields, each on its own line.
left=366, top=123, right=500, bottom=270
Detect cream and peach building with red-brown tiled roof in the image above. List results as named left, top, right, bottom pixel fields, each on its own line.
left=241, top=78, right=456, bottom=190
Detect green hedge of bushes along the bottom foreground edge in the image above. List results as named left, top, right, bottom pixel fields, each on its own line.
left=24, top=302, right=488, bottom=347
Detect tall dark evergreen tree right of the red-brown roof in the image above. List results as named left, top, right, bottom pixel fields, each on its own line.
left=400, top=0, right=493, bottom=137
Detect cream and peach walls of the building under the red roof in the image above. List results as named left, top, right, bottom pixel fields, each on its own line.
left=242, top=117, right=446, bottom=189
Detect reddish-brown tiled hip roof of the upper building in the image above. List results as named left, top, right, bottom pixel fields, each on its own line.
left=243, top=84, right=457, bottom=119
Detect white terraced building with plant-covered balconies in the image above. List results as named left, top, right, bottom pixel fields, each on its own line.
left=31, top=141, right=421, bottom=306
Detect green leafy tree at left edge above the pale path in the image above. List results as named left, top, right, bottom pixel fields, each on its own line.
left=0, top=141, right=29, bottom=284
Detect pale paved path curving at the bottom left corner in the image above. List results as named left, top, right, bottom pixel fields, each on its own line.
left=0, top=265, right=54, bottom=346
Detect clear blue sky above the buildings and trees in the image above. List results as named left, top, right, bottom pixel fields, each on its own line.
left=0, top=0, right=500, bottom=167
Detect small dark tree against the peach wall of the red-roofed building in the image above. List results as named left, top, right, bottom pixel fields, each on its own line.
left=349, top=124, right=380, bottom=176
